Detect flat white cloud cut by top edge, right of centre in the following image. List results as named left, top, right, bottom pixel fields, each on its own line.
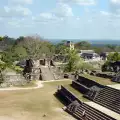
left=59, top=0, right=96, bottom=5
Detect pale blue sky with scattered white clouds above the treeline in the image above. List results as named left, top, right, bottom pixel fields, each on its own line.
left=0, top=0, right=120, bottom=40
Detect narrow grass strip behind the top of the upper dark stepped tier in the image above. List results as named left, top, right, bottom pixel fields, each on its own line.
left=82, top=74, right=116, bottom=85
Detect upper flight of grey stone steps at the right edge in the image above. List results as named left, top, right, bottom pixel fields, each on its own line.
left=93, top=86, right=120, bottom=114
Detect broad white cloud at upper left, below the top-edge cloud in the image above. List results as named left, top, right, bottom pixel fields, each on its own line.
left=1, top=5, right=32, bottom=17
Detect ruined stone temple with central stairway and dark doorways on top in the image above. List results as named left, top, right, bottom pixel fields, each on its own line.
left=23, top=58, right=61, bottom=80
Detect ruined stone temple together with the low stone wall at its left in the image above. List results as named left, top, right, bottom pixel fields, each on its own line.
left=0, top=59, right=60, bottom=87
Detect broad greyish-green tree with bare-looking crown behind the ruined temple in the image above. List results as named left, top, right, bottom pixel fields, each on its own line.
left=2, top=36, right=55, bottom=63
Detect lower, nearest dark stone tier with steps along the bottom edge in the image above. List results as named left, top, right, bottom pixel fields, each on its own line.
left=56, top=86, right=116, bottom=120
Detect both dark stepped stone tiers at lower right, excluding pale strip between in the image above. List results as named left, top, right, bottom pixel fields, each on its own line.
left=56, top=76, right=120, bottom=120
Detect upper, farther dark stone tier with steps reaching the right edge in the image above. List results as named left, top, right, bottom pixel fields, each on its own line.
left=72, top=76, right=120, bottom=114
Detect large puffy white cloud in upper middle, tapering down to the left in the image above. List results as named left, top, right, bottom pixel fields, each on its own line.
left=32, top=3, right=73, bottom=24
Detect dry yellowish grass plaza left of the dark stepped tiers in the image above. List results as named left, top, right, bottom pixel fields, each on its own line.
left=0, top=80, right=74, bottom=120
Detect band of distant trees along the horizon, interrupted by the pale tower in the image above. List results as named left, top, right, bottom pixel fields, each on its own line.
left=0, top=35, right=120, bottom=62
